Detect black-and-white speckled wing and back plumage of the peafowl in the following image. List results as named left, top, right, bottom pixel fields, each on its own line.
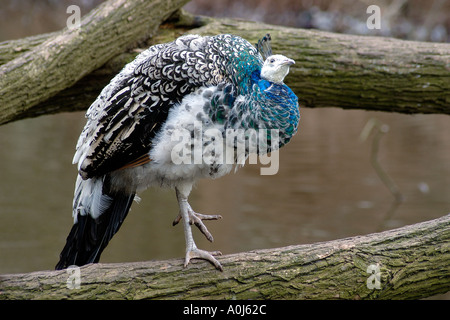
left=73, top=35, right=263, bottom=179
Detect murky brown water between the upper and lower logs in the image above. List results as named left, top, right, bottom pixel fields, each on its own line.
left=0, top=108, right=450, bottom=274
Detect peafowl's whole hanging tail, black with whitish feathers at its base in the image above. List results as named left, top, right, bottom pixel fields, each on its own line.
left=55, top=175, right=135, bottom=270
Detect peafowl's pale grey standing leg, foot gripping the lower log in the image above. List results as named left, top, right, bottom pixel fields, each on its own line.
left=176, top=188, right=223, bottom=271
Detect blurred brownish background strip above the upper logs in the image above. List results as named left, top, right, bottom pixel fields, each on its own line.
left=0, top=0, right=450, bottom=42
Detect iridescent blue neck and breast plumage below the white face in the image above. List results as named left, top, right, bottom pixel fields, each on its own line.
left=205, top=46, right=300, bottom=151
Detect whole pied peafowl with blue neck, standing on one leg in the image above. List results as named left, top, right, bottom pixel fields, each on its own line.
left=56, top=34, right=300, bottom=271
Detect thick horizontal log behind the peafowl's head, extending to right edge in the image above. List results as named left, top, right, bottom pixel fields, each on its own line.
left=192, top=19, right=450, bottom=114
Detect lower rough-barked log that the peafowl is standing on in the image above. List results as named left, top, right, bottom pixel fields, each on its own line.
left=0, top=215, right=450, bottom=299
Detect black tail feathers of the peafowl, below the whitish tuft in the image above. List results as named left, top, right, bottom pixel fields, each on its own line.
left=55, top=185, right=135, bottom=270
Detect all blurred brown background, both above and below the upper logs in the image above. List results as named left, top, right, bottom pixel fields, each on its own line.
left=0, top=0, right=450, bottom=300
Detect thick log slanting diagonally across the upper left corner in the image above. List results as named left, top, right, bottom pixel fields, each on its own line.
left=0, top=0, right=187, bottom=123
